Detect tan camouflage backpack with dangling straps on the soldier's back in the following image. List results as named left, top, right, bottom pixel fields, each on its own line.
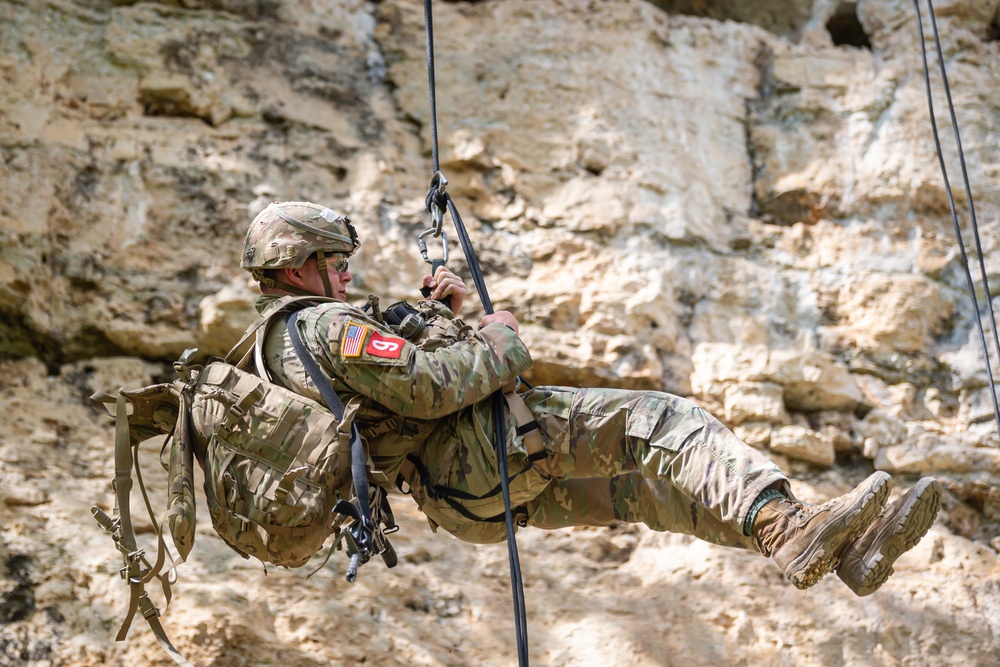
left=91, top=297, right=396, bottom=665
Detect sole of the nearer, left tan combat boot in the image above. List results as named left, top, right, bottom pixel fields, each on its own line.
left=785, top=472, right=892, bottom=589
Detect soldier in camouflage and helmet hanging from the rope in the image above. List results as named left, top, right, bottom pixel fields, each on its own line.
left=241, top=202, right=942, bottom=595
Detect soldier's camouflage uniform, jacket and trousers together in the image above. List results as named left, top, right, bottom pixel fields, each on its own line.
left=258, top=296, right=787, bottom=549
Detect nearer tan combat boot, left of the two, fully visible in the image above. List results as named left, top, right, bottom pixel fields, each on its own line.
left=753, top=472, right=892, bottom=588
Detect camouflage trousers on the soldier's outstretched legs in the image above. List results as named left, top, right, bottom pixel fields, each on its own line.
left=406, top=387, right=787, bottom=548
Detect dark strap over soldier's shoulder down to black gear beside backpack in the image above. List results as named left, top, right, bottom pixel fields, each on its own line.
left=285, top=311, right=385, bottom=583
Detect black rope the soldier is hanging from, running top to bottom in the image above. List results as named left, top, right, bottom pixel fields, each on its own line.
left=424, top=0, right=528, bottom=667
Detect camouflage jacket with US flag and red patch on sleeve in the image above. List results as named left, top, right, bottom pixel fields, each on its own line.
left=257, top=296, right=532, bottom=493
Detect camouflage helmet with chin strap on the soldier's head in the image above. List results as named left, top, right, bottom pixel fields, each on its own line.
left=240, top=202, right=360, bottom=293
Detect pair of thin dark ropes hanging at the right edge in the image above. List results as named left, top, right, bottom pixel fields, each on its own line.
left=913, top=0, right=1000, bottom=435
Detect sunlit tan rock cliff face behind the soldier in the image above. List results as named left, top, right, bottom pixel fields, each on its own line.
left=0, top=0, right=1000, bottom=666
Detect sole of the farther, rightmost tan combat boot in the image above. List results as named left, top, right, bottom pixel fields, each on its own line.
left=838, top=478, right=944, bottom=597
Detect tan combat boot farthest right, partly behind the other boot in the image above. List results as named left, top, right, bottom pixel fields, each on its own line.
left=837, top=477, right=944, bottom=597
